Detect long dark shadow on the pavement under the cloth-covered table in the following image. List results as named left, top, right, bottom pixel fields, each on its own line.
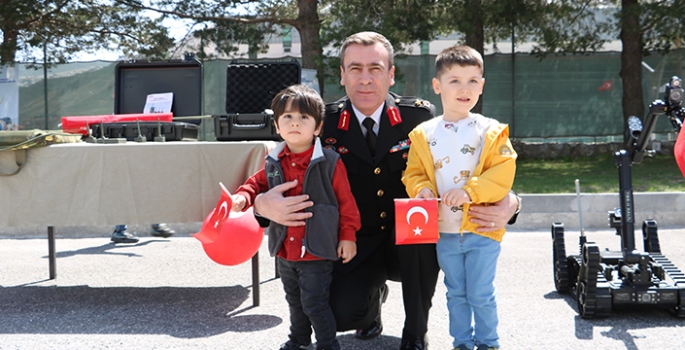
left=0, top=286, right=283, bottom=338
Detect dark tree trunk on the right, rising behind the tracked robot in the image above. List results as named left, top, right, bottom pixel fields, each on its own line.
left=619, top=0, right=645, bottom=141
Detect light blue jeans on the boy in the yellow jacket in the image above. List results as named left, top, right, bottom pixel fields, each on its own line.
left=436, top=232, right=501, bottom=349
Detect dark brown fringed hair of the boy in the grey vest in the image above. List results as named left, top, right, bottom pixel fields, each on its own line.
left=271, top=84, right=326, bottom=127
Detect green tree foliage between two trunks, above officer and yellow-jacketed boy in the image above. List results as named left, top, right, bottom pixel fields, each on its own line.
left=323, top=0, right=606, bottom=112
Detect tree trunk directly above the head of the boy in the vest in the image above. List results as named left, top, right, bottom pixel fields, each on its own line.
left=295, top=0, right=325, bottom=96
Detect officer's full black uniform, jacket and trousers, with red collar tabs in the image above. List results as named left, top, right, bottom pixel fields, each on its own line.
left=322, top=93, right=439, bottom=338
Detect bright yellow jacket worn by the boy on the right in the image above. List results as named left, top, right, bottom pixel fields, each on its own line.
left=402, top=116, right=516, bottom=242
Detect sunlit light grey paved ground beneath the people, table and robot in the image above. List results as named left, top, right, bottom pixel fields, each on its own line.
left=0, top=229, right=685, bottom=350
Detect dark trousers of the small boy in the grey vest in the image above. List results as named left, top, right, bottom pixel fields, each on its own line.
left=277, top=258, right=340, bottom=349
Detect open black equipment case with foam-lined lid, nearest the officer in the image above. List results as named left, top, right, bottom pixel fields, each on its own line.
left=212, top=59, right=302, bottom=141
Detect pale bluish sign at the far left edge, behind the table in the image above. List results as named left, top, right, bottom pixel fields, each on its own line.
left=0, top=65, right=19, bottom=130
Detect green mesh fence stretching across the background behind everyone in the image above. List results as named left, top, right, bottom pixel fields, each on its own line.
left=13, top=50, right=685, bottom=141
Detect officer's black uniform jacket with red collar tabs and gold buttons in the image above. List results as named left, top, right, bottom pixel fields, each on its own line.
left=321, top=93, right=435, bottom=273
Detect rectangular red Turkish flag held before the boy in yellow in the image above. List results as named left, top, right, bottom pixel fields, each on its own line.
left=395, top=198, right=439, bottom=244
